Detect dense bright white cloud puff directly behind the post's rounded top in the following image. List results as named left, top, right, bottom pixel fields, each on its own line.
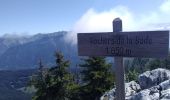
left=73, top=6, right=135, bottom=32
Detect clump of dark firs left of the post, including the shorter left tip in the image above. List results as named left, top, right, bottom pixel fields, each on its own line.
left=32, top=52, right=78, bottom=100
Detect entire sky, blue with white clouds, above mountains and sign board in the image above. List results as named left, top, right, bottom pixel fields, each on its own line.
left=0, top=0, right=170, bottom=36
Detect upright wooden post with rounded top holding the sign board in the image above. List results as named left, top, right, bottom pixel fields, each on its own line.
left=113, top=18, right=125, bottom=100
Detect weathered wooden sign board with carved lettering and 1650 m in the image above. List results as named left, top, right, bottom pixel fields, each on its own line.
left=78, top=31, right=169, bottom=58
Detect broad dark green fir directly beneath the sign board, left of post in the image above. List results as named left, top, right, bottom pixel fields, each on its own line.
left=80, top=57, right=114, bottom=100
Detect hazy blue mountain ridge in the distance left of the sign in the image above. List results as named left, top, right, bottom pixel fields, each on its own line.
left=0, top=31, right=78, bottom=69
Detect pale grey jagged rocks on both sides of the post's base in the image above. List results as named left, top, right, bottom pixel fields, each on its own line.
left=101, top=68, right=170, bottom=100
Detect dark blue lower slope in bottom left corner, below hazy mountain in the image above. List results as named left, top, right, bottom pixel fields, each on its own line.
left=0, top=70, right=36, bottom=100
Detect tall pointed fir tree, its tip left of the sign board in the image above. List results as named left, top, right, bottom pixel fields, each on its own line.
left=49, top=52, right=73, bottom=100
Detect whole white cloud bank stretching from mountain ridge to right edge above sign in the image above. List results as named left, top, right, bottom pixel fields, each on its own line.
left=65, top=0, right=170, bottom=44
